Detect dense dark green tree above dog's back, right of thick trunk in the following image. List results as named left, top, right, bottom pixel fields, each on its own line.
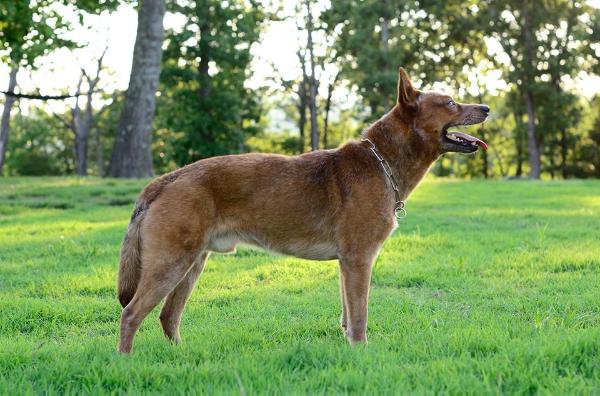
left=157, top=0, right=265, bottom=165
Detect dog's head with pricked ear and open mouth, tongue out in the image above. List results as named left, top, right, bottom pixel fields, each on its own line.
left=397, top=68, right=490, bottom=154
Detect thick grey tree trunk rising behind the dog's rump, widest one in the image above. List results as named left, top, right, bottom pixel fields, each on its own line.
left=108, top=0, right=165, bottom=177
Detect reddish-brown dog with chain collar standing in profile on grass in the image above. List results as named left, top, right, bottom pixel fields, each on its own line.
left=118, top=69, right=489, bottom=353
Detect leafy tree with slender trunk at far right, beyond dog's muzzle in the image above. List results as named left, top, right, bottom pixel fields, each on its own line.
left=479, top=0, right=597, bottom=179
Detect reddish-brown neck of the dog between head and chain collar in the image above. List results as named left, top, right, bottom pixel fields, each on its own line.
left=363, top=107, right=438, bottom=199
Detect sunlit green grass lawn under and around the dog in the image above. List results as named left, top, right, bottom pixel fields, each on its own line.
left=0, top=178, right=600, bottom=394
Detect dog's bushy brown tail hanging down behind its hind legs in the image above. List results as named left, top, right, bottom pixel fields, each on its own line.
left=117, top=198, right=148, bottom=308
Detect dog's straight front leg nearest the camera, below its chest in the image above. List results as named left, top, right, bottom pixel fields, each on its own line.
left=340, top=257, right=373, bottom=345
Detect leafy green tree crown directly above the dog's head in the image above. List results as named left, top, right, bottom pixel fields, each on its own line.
left=321, top=0, right=483, bottom=121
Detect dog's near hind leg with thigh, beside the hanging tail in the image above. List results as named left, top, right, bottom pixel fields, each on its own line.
left=119, top=178, right=215, bottom=353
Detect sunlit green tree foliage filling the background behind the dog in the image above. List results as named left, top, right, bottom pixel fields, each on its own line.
left=0, top=0, right=600, bottom=178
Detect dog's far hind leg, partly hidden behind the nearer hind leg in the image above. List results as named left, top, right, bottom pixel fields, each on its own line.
left=160, top=251, right=208, bottom=343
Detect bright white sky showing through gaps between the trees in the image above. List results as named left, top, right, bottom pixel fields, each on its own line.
left=0, top=0, right=600, bottom=111
